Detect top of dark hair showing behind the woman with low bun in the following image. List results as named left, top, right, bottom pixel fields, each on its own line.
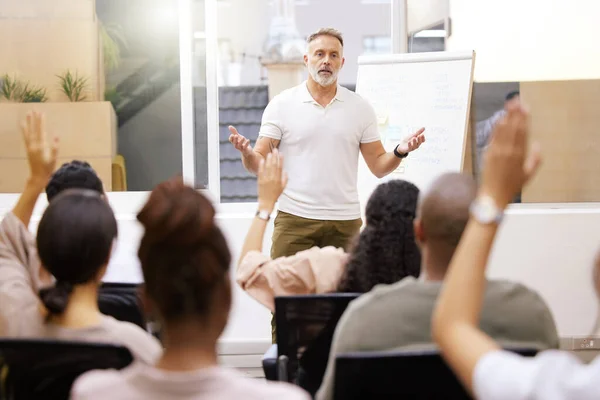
left=46, top=160, right=104, bottom=202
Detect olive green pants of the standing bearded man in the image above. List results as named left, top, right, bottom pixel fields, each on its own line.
left=271, top=211, right=362, bottom=343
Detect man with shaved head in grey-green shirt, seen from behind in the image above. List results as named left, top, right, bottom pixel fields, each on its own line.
left=317, top=173, right=558, bottom=399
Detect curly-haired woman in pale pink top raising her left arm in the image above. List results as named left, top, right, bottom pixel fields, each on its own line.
left=236, top=149, right=421, bottom=311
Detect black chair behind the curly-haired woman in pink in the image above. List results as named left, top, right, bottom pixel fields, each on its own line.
left=263, top=293, right=359, bottom=395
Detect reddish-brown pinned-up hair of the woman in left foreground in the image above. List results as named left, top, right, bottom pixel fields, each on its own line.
left=137, top=178, right=231, bottom=322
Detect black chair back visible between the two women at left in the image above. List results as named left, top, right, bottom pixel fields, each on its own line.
left=98, top=282, right=147, bottom=330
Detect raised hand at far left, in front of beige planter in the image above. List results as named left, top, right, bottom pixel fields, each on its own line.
left=21, top=112, right=58, bottom=184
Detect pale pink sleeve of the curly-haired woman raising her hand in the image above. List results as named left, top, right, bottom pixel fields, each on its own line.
left=236, top=247, right=346, bottom=311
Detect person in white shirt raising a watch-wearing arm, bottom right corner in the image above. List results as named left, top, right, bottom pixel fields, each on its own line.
left=432, top=107, right=600, bottom=400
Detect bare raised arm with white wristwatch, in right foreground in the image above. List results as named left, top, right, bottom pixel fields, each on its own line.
left=432, top=104, right=540, bottom=391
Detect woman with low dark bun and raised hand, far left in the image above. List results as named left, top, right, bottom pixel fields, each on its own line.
left=0, top=114, right=162, bottom=362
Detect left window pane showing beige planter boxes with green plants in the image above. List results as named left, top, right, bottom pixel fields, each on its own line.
left=0, top=0, right=207, bottom=193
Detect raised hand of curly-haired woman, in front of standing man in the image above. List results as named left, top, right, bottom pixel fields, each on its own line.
left=258, top=149, right=288, bottom=212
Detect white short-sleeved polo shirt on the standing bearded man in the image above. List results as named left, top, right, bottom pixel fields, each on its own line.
left=259, top=82, right=380, bottom=220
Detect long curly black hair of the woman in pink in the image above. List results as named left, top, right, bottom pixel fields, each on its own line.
left=338, top=179, right=421, bottom=293
